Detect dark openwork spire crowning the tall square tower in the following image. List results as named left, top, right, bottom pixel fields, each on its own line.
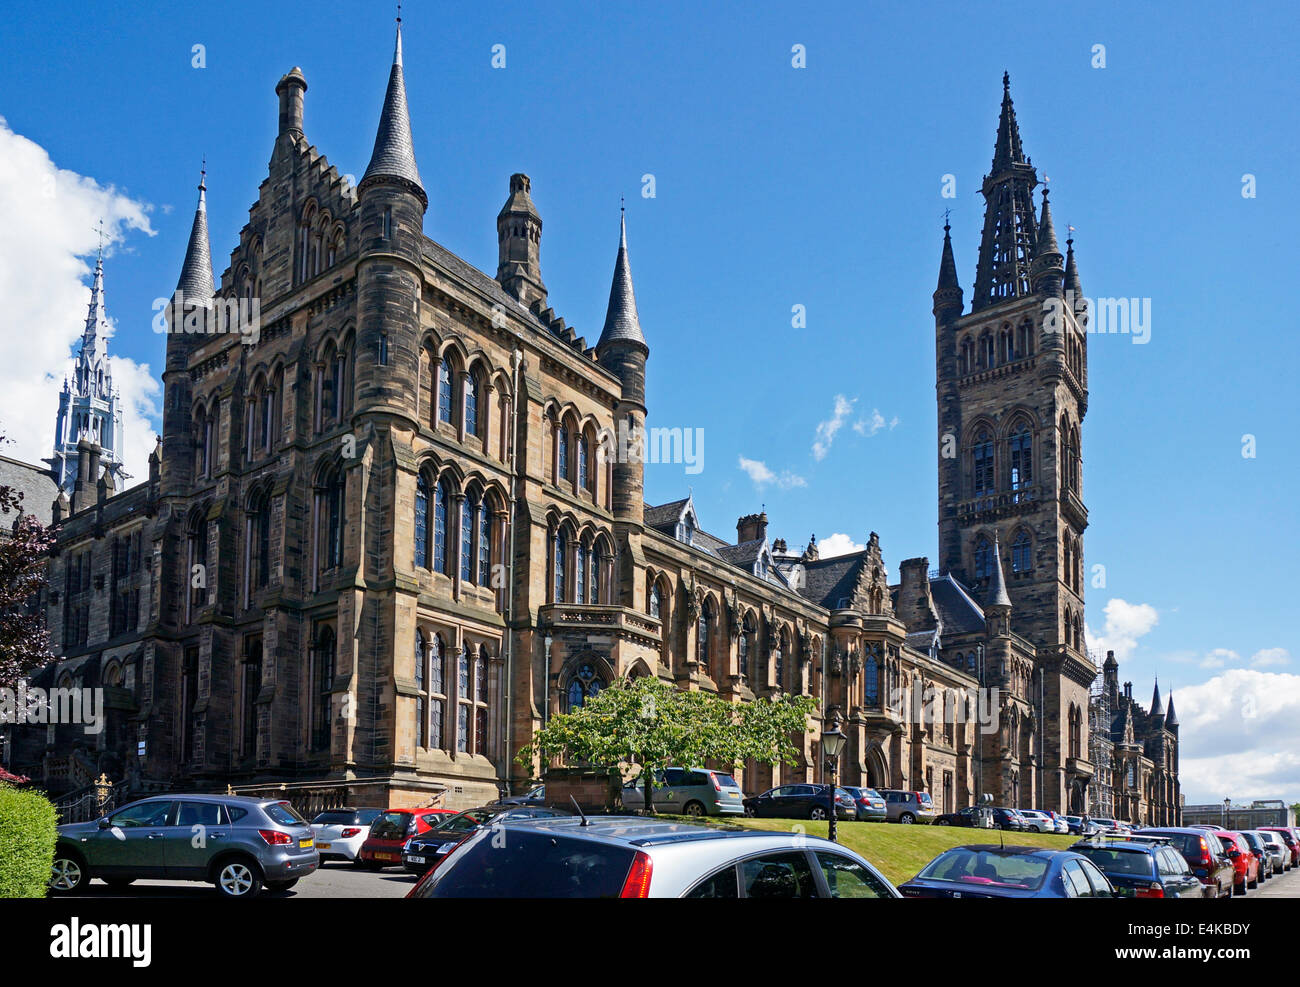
left=971, top=73, right=1039, bottom=311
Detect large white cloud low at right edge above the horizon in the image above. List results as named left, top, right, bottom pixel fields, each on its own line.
left=1175, top=665, right=1300, bottom=802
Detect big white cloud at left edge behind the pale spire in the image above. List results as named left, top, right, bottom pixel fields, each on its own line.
left=0, top=117, right=160, bottom=482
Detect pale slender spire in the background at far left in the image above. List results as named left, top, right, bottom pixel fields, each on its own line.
left=46, top=248, right=126, bottom=492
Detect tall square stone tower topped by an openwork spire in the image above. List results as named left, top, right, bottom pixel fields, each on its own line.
left=933, top=74, right=1096, bottom=809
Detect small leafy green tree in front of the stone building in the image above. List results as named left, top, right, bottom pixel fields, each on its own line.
left=517, top=676, right=816, bottom=813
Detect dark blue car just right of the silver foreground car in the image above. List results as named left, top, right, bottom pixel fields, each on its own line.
left=898, top=845, right=1115, bottom=899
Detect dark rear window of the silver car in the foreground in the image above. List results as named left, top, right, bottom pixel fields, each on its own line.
left=415, top=830, right=636, bottom=899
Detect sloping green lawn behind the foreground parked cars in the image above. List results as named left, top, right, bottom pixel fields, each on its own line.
left=673, top=817, right=1079, bottom=884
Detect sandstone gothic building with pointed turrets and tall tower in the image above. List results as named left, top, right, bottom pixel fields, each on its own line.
left=5, top=34, right=1180, bottom=810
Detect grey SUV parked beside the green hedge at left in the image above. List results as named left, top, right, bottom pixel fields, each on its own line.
left=49, top=795, right=320, bottom=899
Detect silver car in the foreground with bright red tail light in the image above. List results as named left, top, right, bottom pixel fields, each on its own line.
left=407, top=815, right=898, bottom=899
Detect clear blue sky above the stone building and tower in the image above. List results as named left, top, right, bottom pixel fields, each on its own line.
left=0, top=1, right=1300, bottom=797
